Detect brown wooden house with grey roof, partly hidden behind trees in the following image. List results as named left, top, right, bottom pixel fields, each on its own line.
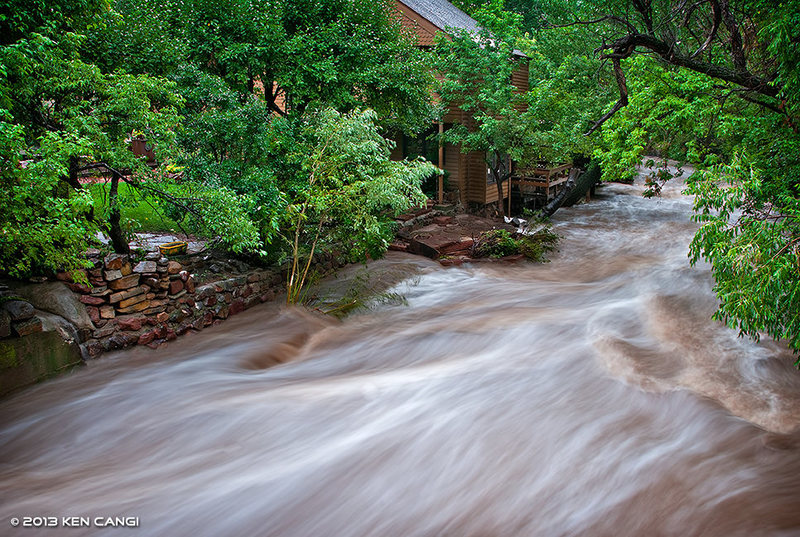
left=393, top=0, right=528, bottom=208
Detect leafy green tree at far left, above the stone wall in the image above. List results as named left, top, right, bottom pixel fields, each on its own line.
left=0, top=4, right=183, bottom=276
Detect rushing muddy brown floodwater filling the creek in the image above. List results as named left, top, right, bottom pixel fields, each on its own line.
left=0, top=169, right=800, bottom=537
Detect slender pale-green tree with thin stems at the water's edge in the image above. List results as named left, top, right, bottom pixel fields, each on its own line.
left=287, top=108, right=438, bottom=303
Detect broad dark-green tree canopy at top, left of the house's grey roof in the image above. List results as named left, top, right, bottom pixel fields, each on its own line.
left=93, top=0, right=433, bottom=132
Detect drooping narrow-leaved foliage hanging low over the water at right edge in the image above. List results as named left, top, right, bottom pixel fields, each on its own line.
left=687, top=155, right=800, bottom=356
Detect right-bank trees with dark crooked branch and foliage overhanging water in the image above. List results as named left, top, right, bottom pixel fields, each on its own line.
left=550, top=0, right=800, bottom=351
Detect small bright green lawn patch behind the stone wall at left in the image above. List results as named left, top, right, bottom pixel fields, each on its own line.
left=86, top=182, right=191, bottom=233
